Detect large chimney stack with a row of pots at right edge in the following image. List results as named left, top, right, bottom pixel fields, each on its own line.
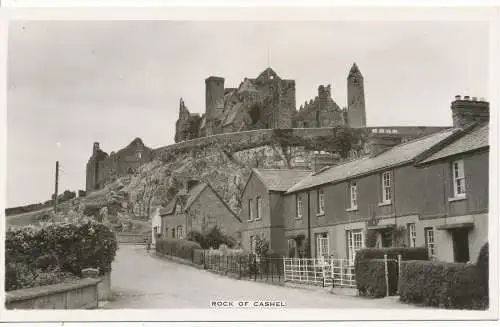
left=451, top=95, right=490, bottom=128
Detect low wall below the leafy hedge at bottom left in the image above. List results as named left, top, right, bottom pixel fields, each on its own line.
left=5, top=278, right=101, bottom=310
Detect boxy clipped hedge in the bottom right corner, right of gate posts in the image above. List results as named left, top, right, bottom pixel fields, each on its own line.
left=399, top=261, right=488, bottom=309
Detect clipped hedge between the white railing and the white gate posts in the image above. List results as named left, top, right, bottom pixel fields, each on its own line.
left=354, top=247, right=428, bottom=297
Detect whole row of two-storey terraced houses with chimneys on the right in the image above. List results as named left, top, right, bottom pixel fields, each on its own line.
left=240, top=96, right=489, bottom=262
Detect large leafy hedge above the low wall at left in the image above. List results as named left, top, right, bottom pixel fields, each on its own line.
left=5, top=219, right=117, bottom=289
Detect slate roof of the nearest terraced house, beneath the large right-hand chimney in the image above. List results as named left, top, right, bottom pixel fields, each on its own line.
left=420, top=124, right=489, bottom=163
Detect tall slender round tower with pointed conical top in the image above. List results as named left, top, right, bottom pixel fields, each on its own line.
left=347, top=63, right=366, bottom=128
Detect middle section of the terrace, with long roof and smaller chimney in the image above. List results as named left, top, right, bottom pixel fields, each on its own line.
left=283, top=128, right=458, bottom=262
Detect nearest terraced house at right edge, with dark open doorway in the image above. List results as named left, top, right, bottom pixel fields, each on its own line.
left=417, top=124, right=489, bottom=262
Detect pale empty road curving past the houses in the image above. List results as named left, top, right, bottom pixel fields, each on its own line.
left=103, top=244, right=413, bottom=309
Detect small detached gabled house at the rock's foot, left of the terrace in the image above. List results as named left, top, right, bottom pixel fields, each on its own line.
left=160, top=180, right=241, bottom=239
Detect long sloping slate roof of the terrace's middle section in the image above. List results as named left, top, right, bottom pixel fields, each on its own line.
left=287, top=129, right=458, bottom=193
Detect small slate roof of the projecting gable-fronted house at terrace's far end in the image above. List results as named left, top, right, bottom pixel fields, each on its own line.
left=252, top=168, right=312, bottom=192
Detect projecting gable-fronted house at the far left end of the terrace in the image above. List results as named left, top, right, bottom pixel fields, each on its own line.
left=240, top=169, right=311, bottom=255
